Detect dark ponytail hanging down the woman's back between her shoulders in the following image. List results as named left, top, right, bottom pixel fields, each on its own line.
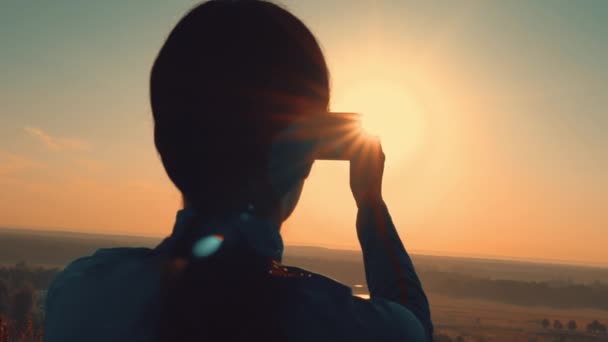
left=158, top=212, right=286, bottom=342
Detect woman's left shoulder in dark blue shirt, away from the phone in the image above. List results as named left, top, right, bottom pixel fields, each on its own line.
left=45, top=248, right=160, bottom=341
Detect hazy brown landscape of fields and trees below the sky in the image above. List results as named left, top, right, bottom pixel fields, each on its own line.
left=0, top=228, right=608, bottom=341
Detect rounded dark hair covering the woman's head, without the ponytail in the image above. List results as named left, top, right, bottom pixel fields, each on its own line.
left=150, top=0, right=329, bottom=216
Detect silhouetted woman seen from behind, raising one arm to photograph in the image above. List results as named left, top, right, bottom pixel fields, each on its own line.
left=45, top=0, right=432, bottom=342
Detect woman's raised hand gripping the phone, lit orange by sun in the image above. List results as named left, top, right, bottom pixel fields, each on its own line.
left=350, top=135, right=385, bottom=208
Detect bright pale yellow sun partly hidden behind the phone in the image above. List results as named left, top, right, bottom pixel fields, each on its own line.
left=332, top=81, right=426, bottom=163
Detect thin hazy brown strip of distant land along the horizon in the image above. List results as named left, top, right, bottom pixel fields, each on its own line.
left=0, top=228, right=608, bottom=284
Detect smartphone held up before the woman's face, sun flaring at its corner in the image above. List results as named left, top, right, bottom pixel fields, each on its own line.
left=313, top=112, right=362, bottom=160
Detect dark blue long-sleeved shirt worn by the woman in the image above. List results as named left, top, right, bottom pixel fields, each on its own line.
left=44, top=204, right=433, bottom=342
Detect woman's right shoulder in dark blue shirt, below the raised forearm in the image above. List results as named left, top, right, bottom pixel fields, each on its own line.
left=279, top=266, right=427, bottom=341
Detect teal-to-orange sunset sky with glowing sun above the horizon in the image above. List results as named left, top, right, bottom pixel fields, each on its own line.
left=0, top=0, right=608, bottom=265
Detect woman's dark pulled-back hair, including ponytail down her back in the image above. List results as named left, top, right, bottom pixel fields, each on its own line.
left=150, top=0, right=329, bottom=341
